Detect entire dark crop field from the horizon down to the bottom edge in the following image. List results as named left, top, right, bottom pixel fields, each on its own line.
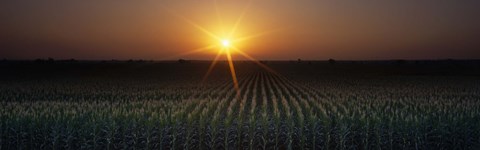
left=0, top=61, right=480, bottom=149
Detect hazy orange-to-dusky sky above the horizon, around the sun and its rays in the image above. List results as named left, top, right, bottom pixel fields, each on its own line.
left=0, top=0, right=480, bottom=60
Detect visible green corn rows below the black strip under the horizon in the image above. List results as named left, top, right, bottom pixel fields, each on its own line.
left=0, top=64, right=480, bottom=149
